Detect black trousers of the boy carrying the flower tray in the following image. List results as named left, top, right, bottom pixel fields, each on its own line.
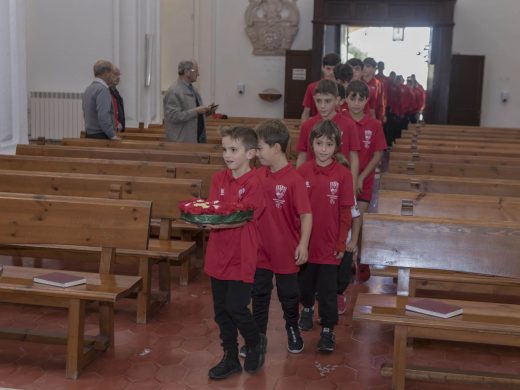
left=211, top=278, right=260, bottom=351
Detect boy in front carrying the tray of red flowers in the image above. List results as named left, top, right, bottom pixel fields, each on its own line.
left=204, top=127, right=267, bottom=379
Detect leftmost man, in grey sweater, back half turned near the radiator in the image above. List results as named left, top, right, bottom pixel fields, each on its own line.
left=83, top=60, right=118, bottom=139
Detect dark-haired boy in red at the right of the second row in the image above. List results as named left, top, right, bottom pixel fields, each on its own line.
left=346, top=81, right=386, bottom=281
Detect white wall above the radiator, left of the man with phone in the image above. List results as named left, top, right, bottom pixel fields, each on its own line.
left=26, top=0, right=162, bottom=127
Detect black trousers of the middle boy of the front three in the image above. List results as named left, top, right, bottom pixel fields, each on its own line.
left=253, top=268, right=299, bottom=334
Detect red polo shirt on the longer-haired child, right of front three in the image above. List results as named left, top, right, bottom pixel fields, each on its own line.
left=298, top=160, right=354, bottom=265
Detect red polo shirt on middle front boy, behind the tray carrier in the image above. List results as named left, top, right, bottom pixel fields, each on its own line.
left=257, top=164, right=311, bottom=274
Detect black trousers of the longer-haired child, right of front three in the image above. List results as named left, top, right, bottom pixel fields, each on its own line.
left=299, top=263, right=338, bottom=329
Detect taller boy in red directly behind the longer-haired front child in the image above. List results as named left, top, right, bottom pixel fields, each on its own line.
left=296, top=80, right=360, bottom=189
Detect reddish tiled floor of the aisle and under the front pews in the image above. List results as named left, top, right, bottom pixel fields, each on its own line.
left=0, top=258, right=520, bottom=390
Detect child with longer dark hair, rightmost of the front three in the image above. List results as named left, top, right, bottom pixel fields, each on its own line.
left=298, top=120, right=354, bottom=352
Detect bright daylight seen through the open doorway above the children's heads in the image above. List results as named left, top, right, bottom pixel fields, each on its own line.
left=341, top=25, right=432, bottom=88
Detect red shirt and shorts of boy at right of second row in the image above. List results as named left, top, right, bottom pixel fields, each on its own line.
left=348, top=114, right=387, bottom=201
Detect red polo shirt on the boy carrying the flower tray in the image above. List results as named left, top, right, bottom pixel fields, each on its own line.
left=204, top=169, right=265, bottom=283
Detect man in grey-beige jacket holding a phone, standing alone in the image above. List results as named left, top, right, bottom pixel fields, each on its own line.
left=163, top=60, right=217, bottom=143
